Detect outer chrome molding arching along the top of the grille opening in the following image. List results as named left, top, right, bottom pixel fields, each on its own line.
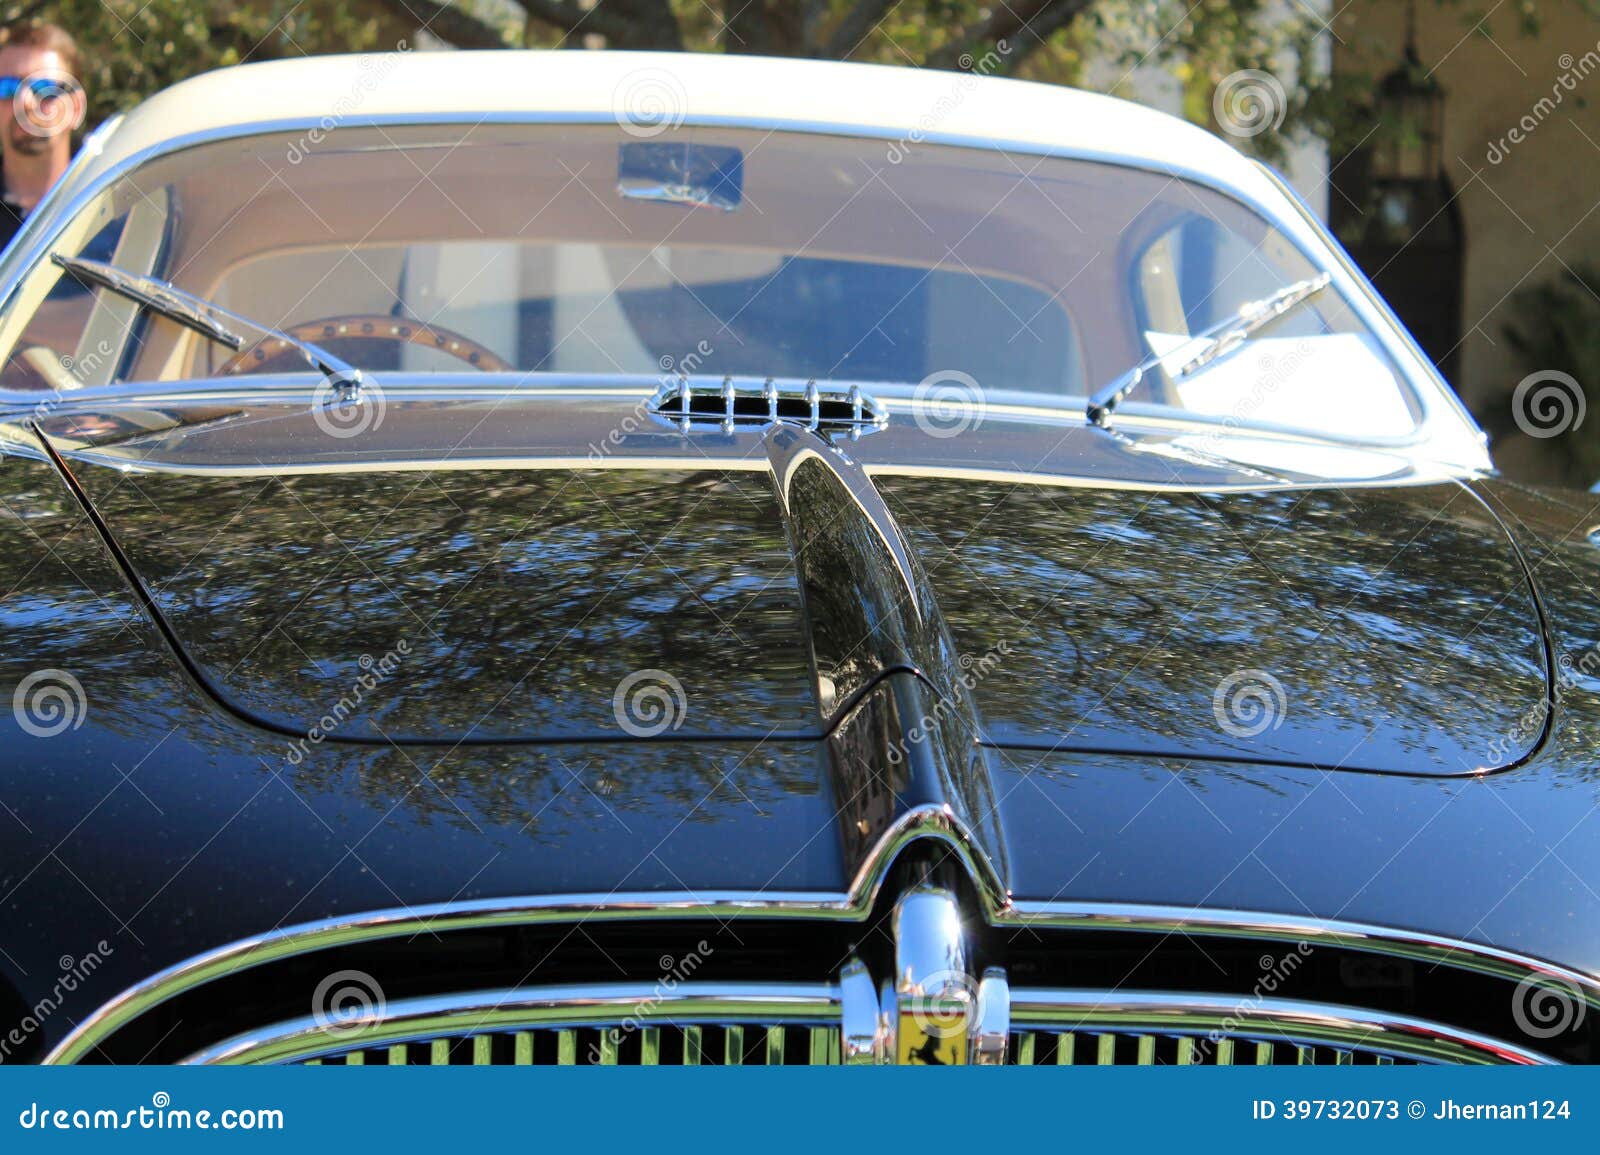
left=43, top=889, right=1600, bottom=1064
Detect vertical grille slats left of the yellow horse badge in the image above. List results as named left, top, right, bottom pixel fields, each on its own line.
left=302, top=1024, right=840, bottom=1067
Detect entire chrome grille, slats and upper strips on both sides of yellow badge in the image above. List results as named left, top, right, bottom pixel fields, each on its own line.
left=187, top=968, right=1541, bottom=1067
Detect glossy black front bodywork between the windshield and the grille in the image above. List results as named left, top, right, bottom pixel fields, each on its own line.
left=0, top=405, right=1600, bottom=1062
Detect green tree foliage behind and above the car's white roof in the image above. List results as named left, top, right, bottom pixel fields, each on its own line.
left=0, top=0, right=1600, bottom=160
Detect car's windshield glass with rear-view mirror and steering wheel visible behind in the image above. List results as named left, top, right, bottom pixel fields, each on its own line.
left=0, top=125, right=1418, bottom=437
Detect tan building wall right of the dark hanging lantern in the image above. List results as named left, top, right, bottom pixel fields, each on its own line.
left=1333, top=0, right=1600, bottom=480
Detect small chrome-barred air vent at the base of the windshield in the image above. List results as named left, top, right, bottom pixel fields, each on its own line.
left=650, top=378, right=888, bottom=438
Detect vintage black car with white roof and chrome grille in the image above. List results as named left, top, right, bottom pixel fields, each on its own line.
left=0, top=53, right=1600, bottom=1065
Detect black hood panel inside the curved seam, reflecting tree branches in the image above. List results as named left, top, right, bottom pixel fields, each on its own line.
left=46, top=391, right=1549, bottom=774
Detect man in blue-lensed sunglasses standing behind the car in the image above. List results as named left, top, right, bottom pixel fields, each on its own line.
left=0, top=22, right=88, bottom=246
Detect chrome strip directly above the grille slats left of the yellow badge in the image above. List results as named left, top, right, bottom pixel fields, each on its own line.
left=182, top=982, right=840, bottom=1064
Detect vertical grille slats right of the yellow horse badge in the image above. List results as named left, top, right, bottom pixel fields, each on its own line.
left=1010, top=1030, right=1414, bottom=1067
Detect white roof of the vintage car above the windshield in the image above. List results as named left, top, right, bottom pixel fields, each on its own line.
left=74, top=50, right=1270, bottom=200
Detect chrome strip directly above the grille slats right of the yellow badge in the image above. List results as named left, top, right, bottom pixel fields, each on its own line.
left=1011, top=989, right=1554, bottom=1065
